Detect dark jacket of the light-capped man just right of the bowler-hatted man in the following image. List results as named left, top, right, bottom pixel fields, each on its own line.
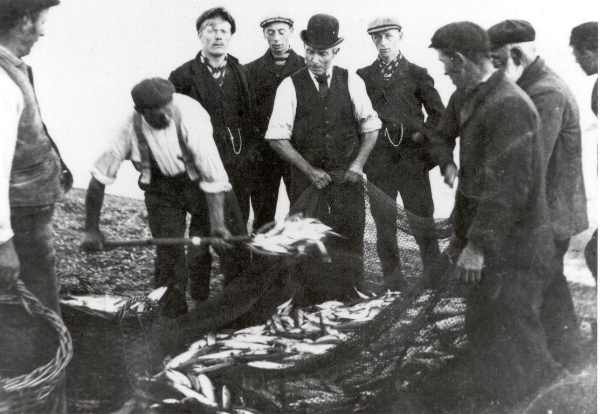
left=357, top=57, right=444, bottom=167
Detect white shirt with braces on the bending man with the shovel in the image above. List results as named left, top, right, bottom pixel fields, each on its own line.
left=91, top=93, right=231, bottom=193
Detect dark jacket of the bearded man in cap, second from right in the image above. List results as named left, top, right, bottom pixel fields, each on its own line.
left=517, top=58, right=588, bottom=240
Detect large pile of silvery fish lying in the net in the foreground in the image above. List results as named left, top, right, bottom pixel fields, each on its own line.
left=140, top=291, right=400, bottom=413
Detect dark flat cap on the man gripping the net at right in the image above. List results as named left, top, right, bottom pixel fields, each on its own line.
left=429, top=22, right=490, bottom=54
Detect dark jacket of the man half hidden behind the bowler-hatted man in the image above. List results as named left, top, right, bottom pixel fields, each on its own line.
left=245, top=50, right=305, bottom=138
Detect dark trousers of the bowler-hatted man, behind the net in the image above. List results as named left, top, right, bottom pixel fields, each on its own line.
left=290, top=178, right=365, bottom=304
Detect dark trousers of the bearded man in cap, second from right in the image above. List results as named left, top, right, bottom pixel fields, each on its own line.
left=541, top=239, right=579, bottom=364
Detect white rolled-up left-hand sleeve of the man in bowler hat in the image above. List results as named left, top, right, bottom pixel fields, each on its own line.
left=265, top=77, right=298, bottom=140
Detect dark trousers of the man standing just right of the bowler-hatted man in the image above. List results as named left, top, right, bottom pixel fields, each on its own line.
left=367, top=158, right=440, bottom=278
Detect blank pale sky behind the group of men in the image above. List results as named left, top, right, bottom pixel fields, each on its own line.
left=26, top=0, right=598, bottom=220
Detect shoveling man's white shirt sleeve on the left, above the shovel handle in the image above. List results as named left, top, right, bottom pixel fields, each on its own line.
left=90, top=118, right=134, bottom=185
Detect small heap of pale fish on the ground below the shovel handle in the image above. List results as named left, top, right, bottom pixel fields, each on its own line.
left=60, top=286, right=167, bottom=319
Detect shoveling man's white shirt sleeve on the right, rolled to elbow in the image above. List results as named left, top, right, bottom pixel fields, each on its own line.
left=182, top=102, right=231, bottom=193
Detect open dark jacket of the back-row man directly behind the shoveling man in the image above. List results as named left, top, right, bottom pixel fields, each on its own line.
left=169, top=54, right=258, bottom=168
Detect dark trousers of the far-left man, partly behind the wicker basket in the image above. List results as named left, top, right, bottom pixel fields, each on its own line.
left=0, top=205, right=67, bottom=414
